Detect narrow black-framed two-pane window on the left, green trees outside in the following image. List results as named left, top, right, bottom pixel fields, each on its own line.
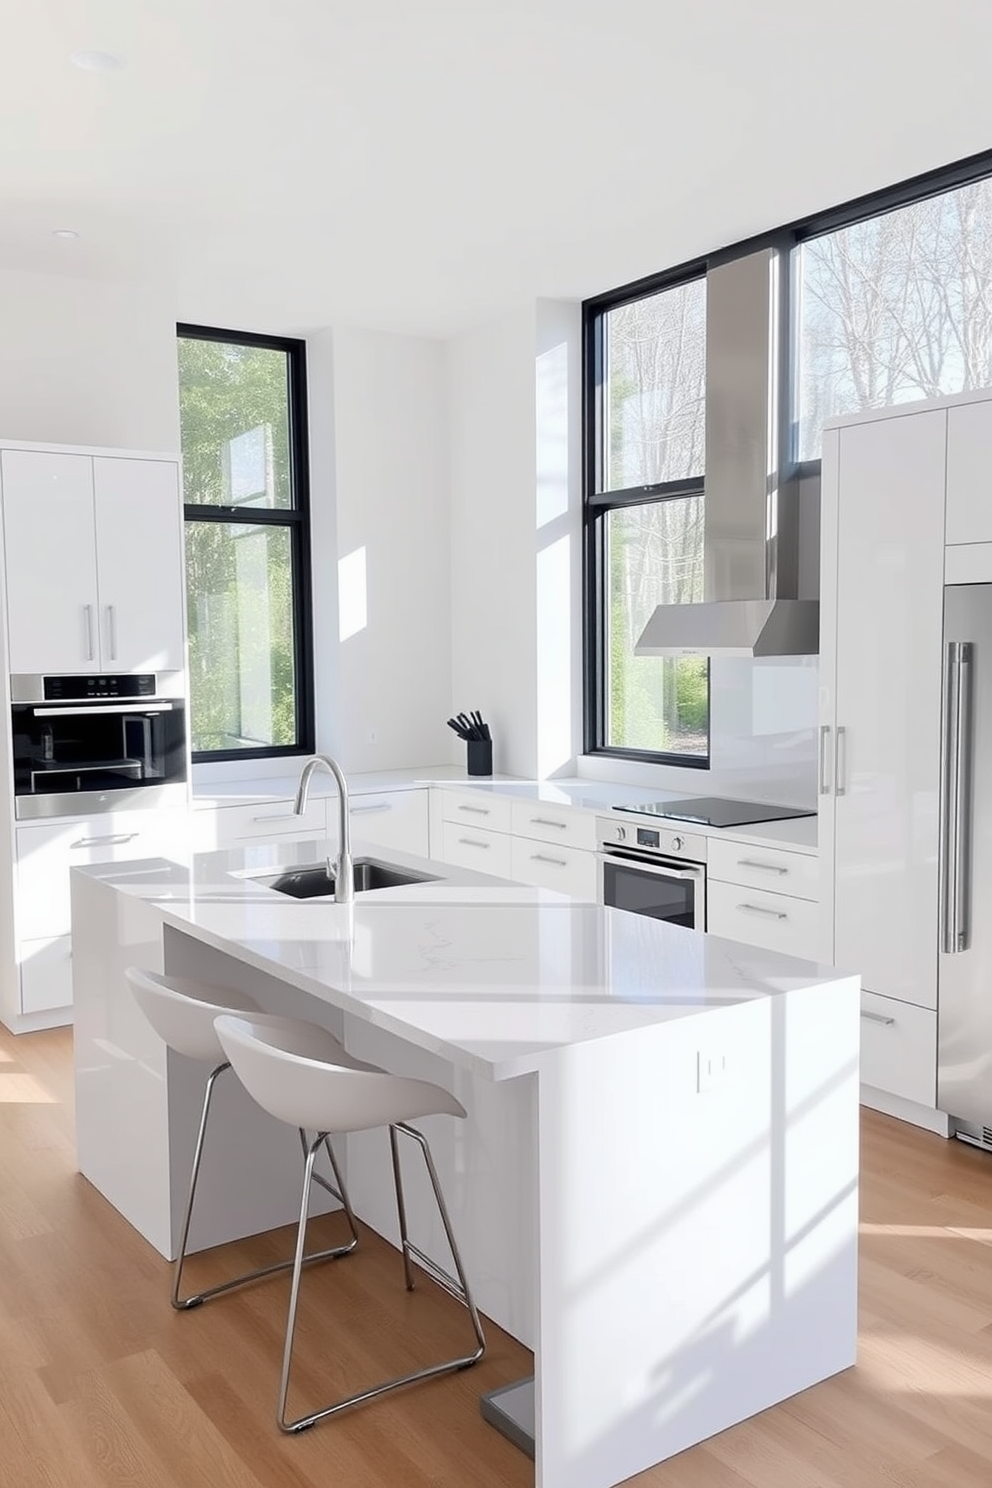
left=177, top=324, right=314, bottom=760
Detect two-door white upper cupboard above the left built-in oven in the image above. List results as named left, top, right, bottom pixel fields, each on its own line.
left=0, top=449, right=184, bottom=673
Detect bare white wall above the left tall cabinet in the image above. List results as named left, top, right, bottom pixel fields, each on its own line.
left=0, top=269, right=178, bottom=451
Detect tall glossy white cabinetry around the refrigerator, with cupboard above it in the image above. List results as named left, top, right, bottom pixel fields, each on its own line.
left=819, top=391, right=992, bottom=1132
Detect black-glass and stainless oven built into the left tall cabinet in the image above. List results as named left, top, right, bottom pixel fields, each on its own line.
left=10, top=698, right=186, bottom=817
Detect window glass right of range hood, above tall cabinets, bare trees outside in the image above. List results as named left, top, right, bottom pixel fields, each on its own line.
left=796, top=180, right=992, bottom=460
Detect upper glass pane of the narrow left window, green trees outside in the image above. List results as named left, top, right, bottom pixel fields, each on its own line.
left=178, top=336, right=293, bottom=507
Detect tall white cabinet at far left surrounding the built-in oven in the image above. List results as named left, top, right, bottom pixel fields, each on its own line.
left=0, top=440, right=186, bottom=1033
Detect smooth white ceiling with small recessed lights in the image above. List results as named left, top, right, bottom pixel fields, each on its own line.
left=0, top=0, right=992, bottom=336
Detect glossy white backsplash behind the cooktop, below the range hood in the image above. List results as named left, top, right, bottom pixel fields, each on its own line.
left=577, top=656, right=819, bottom=808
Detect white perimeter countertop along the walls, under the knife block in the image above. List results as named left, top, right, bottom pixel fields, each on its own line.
left=193, top=765, right=817, bottom=853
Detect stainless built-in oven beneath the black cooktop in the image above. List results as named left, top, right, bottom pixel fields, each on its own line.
left=598, top=817, right=706, bottom=930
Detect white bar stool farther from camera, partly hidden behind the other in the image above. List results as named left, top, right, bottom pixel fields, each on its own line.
left=123, top=966, right=361, bottom=1312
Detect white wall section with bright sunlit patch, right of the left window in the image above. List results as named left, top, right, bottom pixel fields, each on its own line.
left=308, top=327, right=451, bottom=771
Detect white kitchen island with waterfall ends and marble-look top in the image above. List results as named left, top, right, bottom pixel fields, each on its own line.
left=73, top=844, right=858, bottom=1488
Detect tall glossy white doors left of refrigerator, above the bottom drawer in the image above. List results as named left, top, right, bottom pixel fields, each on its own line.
left=819, top=409, right=947, bottom=1009
